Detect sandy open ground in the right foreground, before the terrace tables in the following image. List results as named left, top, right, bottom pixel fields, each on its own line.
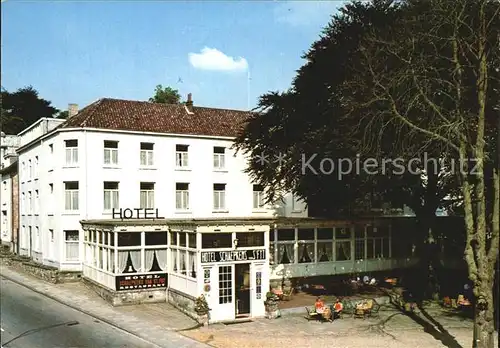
left=185, top=305, right=498, bottom=348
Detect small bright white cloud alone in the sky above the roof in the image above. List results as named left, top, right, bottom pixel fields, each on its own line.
left=188, top=47, right=248, bottom=71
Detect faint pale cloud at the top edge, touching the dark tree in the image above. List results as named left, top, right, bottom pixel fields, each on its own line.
left=274, top=1, right=345, bottom=26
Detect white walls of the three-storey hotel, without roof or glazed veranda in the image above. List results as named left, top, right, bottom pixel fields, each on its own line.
left=19, top=120, right=307, bottom=270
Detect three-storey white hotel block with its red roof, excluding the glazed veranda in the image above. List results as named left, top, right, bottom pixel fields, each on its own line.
left=18, top=95, right=307, bottom=271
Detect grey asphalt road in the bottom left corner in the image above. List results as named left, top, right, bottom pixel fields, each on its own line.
left=0, top=277, right=157, bottom=348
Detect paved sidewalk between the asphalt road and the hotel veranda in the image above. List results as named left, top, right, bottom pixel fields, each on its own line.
left=0, top=265, right=208, bottom=348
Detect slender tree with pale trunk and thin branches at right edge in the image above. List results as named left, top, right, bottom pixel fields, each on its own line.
left=344, top=0, right=500, bottom=347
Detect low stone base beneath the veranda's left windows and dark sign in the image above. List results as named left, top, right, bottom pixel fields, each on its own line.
left=82, top=277, right=167, bottom=307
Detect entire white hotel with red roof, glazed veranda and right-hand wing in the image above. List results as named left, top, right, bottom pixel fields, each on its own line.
left=14, top=96, right=411, bottom=322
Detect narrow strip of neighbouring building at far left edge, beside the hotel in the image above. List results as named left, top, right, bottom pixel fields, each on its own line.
left=0, top=132, right=19, bottom=252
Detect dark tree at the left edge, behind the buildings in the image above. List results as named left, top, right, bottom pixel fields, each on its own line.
left=1, top=86, right=59, bottom=134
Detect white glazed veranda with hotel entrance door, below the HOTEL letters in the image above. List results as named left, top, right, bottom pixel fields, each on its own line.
left=82, top=219, right=272, bottom=322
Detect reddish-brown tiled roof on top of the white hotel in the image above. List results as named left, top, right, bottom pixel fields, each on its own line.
left=60, top=98, right=251, bottom=137
